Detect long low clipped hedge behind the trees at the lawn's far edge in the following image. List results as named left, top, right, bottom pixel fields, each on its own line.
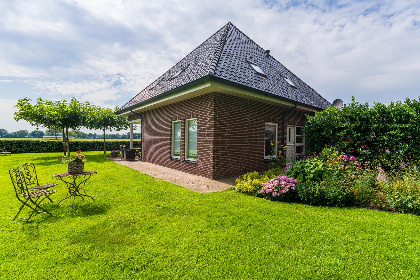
left=0, top=139, right=135, bottom=153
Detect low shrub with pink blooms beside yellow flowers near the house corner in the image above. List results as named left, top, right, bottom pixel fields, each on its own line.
left=260, top=175, right=298, bottom=200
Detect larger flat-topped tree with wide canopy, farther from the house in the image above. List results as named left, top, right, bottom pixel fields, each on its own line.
left=14, top=97, right=91, bottom=156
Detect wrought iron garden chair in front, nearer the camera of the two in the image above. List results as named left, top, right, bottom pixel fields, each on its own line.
left=9, top=169, right=56, bottom=222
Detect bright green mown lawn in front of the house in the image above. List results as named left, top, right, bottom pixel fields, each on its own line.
left=0, top=152, right=420, bottom=279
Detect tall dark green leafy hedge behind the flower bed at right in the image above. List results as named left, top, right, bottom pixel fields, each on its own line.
left=305, top=98, right=420, bottom=170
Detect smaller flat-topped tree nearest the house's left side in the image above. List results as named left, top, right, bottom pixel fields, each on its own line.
left=88, top=106, right=129, bottom=154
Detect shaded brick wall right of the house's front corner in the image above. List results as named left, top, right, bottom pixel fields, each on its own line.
left=214, top=93, right=305, bottom=178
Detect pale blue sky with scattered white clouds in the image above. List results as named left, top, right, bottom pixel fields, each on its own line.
left=0, top=0, right=420, bottom=133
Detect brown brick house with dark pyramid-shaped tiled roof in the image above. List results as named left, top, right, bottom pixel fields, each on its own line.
left=116, top=23, right=331, bottom=179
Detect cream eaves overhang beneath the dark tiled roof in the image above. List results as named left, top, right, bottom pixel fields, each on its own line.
left=116, top=75, right=322, bottom=117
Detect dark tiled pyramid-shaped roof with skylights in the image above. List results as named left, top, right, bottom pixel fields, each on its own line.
left=116, top=22, right=331, bottom=114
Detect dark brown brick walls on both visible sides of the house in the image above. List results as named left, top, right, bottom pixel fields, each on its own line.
left=142, top=93, right=306, bottom=178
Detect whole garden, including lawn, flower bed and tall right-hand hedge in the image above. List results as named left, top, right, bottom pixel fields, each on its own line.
left=0, top=98, right=420, bottom=279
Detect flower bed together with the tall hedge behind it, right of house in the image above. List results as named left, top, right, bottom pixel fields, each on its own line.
left=236, top=99, right=420, bottom=215
